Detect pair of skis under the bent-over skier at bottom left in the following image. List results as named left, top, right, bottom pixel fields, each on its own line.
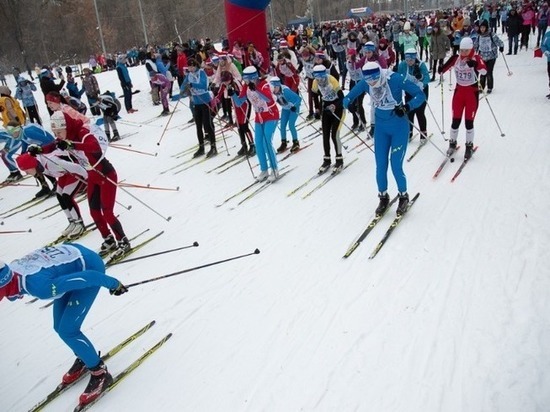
left=30, top=320, right=172, bottom=412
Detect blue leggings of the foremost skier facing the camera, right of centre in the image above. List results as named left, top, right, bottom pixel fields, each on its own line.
left=374, top=116, right=409, bottom=193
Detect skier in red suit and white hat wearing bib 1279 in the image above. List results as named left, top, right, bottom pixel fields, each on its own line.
left=439, top=37, right=487, bottom=160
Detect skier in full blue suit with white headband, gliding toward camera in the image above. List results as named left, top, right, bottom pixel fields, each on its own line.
left=343, top=62, right=426, bottom=215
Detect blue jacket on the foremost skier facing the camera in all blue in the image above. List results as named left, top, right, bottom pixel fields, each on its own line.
left=343, top=69, right=426, bottom=121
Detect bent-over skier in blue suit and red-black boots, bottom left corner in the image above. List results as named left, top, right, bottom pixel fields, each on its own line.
left=0, top=243, right=128, bottom=405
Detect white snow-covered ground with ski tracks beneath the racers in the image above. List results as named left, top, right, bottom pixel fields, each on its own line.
left=0, top=37, right=550, bottom=412
